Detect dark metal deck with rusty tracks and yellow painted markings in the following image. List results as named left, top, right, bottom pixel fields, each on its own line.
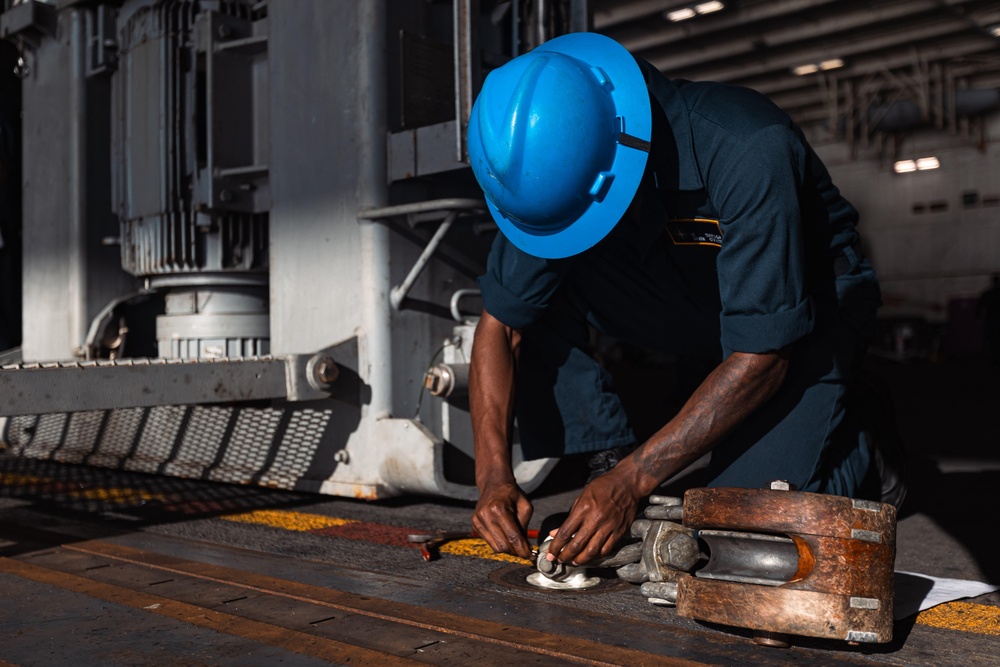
left=0, top=365, right=1000, bottom=666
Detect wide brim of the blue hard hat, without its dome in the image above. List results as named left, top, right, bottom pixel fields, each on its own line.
left=486, top=32, right=652, bottom=259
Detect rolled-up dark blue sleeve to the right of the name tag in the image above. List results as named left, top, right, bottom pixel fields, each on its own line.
left=707, top=125, right=813, bottom=354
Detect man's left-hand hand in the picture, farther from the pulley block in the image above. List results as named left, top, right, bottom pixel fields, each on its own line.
left=472, top=482, right=533, bottom=560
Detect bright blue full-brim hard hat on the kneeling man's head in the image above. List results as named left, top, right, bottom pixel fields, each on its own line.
left=468, top=33, right=652, bottom=258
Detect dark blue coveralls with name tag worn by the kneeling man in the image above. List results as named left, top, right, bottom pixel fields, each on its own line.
left=479, top=61, right=880, bottom=496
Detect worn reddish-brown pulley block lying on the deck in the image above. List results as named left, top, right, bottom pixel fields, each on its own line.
left=677, top=488, right=896, bottom=643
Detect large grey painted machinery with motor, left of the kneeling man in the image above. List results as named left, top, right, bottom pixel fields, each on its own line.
left=0, top=0, right=588, bottom=499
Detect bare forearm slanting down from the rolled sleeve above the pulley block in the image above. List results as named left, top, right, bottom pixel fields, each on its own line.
left=619, top=351, right=788, bottom=497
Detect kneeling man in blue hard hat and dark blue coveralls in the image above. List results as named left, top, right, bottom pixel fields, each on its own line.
left=468, top=33, right=892, bottom=563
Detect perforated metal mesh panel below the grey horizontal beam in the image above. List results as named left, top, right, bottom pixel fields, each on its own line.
left=4, top=406, right=336, bottom=490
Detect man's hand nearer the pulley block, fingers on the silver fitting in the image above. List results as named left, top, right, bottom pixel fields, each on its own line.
left=549, top=468, right=642, bottom=565
